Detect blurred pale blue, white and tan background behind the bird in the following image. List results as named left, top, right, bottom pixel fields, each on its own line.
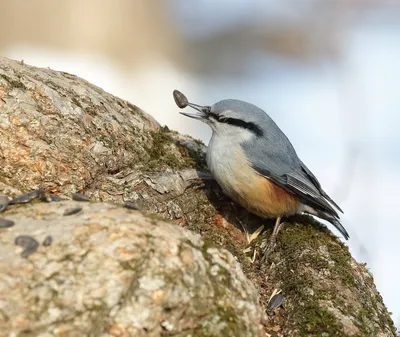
left=0, top=0, right=400, bottom=326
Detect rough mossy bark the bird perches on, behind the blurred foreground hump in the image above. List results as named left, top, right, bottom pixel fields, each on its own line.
left=0, top=59, right=395, bottom=337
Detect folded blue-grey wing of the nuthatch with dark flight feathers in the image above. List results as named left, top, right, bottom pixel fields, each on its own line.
left=242, top=134, right=340, bottom=217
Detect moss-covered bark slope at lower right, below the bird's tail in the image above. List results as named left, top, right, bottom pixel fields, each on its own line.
left=245, top=216, right=395, bottom=337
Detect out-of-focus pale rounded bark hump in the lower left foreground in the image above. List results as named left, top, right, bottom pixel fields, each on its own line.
left=0, top=201, right=262, bottom=337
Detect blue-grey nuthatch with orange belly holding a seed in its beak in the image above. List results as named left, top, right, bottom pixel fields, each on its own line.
left=174, top=90, right=349, bottom=239
